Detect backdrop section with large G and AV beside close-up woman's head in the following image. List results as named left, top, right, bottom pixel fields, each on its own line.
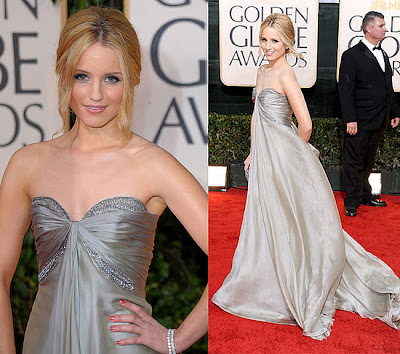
left=125, top=0, right=208, bottom=188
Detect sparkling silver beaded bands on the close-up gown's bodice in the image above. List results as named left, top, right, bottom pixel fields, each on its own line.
left=32, top=197, right=147, bottom=291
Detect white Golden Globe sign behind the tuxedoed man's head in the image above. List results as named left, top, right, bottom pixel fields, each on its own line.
left=337, top=0, right=400, bottom=92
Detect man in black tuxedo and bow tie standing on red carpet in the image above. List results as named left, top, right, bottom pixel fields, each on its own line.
left=339, top=11, right=399, bottom=216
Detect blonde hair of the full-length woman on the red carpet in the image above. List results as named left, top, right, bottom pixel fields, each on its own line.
left=259, top=14, right=303, bottom=58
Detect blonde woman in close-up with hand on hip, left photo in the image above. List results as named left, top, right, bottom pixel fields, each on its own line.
left=0, top=7, right=207, bottom=354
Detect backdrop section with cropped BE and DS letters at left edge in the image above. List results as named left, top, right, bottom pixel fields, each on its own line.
left=0, top=0, right=62, bottom=178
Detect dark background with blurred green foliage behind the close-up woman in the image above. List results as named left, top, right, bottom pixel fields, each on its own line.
left=11, top=0, right=208, bottom=353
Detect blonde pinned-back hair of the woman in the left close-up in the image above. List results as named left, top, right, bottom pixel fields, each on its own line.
left=56, top=6, right=141, bottom=144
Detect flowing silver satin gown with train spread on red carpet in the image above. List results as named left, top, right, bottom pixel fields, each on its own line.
left=212, top=89, right=400, bottom=340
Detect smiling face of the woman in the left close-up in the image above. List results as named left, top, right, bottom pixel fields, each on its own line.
left=70, top=43, right=124, bottom=128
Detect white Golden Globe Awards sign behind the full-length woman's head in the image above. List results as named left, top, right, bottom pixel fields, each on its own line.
left=219, top=0, right=318, bottom=87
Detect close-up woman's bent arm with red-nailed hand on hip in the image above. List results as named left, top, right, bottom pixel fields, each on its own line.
left=112, top=148, right=208, bottom=353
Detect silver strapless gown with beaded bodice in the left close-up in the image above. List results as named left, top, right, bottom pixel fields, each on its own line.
left=23, top=197, right=158, bottom=354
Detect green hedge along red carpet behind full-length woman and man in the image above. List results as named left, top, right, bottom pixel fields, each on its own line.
left=208, top=113, right=400, bottom=171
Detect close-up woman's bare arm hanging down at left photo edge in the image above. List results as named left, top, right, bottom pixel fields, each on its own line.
left=0, top=150, right=31, bottom=354
